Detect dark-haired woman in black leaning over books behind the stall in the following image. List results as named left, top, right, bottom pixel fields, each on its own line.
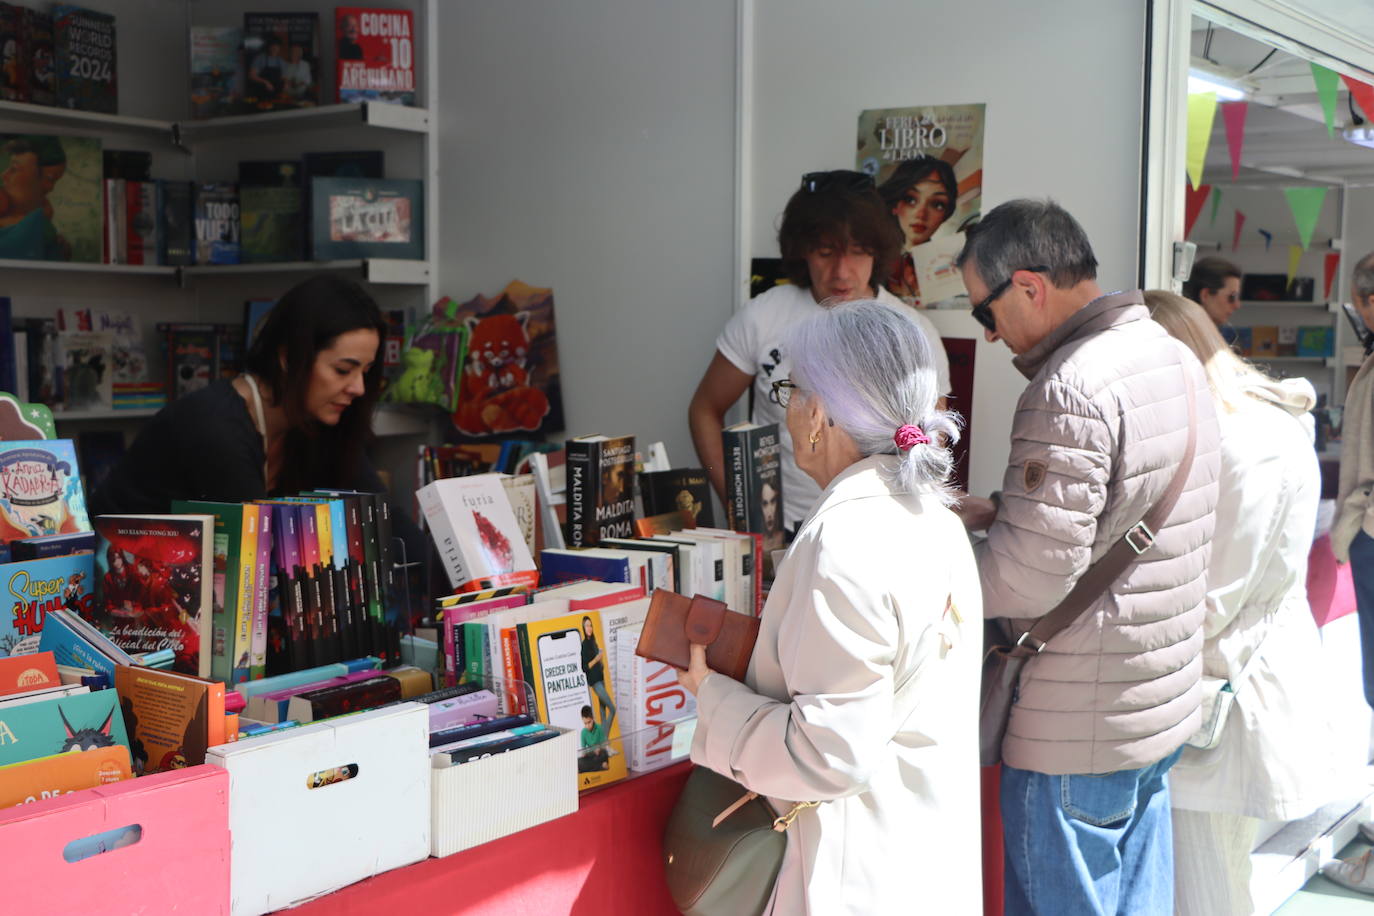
left=91, top=275, right=386, bottom=515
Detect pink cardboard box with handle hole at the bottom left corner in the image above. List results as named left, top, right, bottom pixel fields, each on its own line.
left=0, top=765, right=229, bottom=916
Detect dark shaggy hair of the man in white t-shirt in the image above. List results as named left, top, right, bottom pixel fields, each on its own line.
left=778, top=179, right=901, bottom=291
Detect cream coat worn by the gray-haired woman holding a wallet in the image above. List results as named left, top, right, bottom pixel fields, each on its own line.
left=691, top=456, right=982, bottom=916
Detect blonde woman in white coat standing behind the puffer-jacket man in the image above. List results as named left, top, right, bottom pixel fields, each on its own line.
left=1145, top=290, right=1334, bottom=916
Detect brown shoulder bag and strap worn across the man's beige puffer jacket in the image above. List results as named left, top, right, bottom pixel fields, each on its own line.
left=978, top=369, right=1198, bottom=766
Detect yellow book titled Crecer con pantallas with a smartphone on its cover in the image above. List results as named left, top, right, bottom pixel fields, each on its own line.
left=519, top=611, right=625, bottom=790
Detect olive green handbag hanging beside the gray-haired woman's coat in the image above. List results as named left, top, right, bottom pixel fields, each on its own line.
left=664, top=766, right=819, bottom=916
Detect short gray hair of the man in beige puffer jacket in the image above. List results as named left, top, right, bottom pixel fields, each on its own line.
left=955, top=198, right=1098, bottom=290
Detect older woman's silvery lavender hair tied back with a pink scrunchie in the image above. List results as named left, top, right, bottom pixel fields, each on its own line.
left=783, top=299, right=959, bottom=505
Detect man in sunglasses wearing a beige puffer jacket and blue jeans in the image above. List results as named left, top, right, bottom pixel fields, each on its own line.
left=958, top=201, right=1219, bottom=913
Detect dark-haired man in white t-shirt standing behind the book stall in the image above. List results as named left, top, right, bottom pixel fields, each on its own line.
left=687, top=170, right=949, bottom=531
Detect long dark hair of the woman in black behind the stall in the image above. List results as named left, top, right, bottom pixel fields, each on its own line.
left=243, top=273, right=386, bottom=493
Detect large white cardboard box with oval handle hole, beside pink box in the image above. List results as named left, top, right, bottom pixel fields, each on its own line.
left=206, top=703, right=430, bottom=916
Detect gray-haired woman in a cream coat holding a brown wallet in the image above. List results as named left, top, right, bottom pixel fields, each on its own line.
left=679, top=301, right=982, bottom=915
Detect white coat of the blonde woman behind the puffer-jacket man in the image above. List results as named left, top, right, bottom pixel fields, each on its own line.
left=1169, top=379, right=1333, bottom=820
